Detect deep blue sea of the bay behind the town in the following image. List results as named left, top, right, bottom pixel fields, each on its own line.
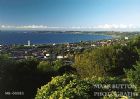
left=0, top=31, right=112, bottom=45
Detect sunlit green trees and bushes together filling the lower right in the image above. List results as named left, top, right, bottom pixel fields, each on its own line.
left=36, top=37, right=140, bottom=99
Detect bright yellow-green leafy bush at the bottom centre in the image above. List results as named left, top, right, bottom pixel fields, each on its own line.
left=35, top=75, right=93, bottom=99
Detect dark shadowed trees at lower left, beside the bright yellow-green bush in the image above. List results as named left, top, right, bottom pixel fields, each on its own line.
left=0, top=54, right=75, bottom=99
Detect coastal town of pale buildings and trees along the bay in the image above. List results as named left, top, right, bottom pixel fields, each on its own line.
left=0, top=37, right=129, bottom=65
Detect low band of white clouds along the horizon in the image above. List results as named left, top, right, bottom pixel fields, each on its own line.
left=0, top=24, right=140, bottom=30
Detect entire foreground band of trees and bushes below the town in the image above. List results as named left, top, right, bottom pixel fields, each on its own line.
left=0, top=37, right=140, bottom=99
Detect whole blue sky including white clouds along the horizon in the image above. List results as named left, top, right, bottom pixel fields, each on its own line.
left=0, top=0, right=140, bottom=31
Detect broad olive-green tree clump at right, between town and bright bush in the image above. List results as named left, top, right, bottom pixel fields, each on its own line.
left=74, top=41, right=139, bottom=77
